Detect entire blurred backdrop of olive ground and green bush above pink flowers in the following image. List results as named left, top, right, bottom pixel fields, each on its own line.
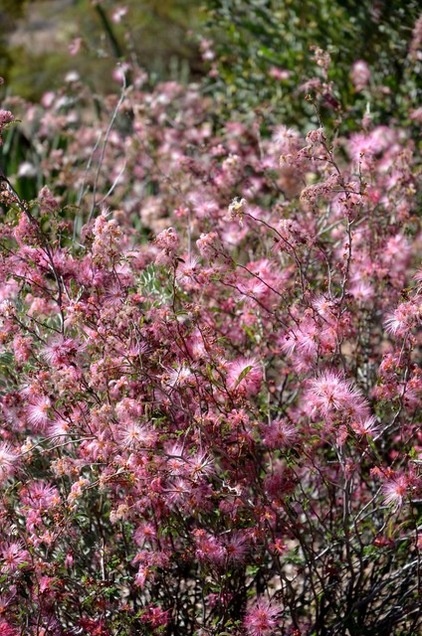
left=0, top=0, right=422, bottom=137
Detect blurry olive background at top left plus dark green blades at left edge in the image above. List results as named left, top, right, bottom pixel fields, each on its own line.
left=0, top=0, right=205, bottom=199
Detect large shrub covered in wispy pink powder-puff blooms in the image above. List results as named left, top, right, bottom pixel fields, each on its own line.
left=0, top=43, right=422, bottom=636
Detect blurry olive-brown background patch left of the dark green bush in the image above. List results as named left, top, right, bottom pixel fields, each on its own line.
left=0, top=0, right=203, bottom=101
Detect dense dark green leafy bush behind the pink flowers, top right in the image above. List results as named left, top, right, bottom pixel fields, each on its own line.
left=205, top=0, right=422, bottom=128
